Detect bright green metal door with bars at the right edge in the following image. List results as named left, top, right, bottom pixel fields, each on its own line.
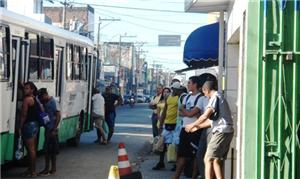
left=257, top=0, right=300, bottom=179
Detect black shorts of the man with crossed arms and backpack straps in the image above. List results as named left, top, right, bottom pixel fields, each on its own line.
left=178, top=128, right=202, bottom=158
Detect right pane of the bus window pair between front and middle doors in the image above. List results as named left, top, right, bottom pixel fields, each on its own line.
left=39, top=37, right=54, bottom=80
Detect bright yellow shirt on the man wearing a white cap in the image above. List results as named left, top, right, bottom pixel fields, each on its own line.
left=165, top=95, right=178, bottom=124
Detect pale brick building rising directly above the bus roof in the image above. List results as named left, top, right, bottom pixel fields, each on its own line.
left=43, top=5, right=95, bottom=40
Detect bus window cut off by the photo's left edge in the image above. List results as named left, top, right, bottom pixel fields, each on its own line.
left=0, top=26, right=9, bottom=81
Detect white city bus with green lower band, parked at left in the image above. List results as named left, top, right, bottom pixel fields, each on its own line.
left=0, top=8, right=98, bottom=164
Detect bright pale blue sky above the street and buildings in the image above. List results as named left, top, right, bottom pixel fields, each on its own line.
left=44, top=0, right=208, bottom=72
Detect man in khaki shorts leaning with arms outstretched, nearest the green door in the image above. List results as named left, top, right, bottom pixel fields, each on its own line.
left=185, top=81, right=234, bottom=179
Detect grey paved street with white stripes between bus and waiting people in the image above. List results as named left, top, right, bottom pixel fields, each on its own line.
left=1, top=104, right=176, bottom=179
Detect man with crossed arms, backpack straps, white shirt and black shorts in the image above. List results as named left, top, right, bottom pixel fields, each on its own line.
left=173, top=76, right=205, bottom=179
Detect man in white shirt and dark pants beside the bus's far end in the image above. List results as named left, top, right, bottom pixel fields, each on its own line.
left=92, top=88, right=107, bottom=145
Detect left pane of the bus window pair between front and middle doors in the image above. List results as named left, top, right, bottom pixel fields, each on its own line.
left=28, top=33, right=39, bottom=80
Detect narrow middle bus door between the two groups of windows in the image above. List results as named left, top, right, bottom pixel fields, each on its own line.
left=55, top=46, right=64, bottom=103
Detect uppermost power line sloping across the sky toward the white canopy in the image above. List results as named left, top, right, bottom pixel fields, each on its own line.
left=72, top=2, right=192, bottom=13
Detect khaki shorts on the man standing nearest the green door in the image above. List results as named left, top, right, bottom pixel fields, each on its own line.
left=205, top=132, right=233, bottom=160
